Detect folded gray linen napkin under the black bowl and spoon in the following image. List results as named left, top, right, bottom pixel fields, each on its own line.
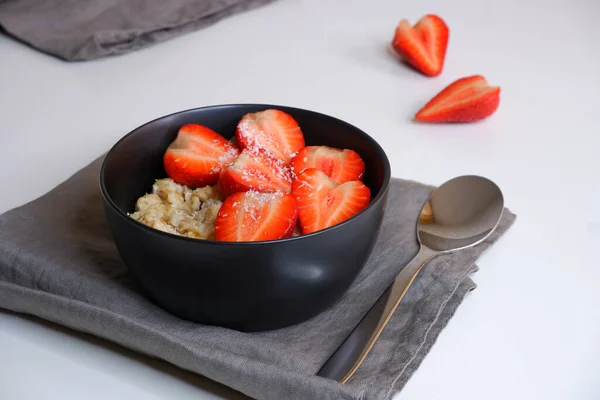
left=0, top=155, right=515, bottom=400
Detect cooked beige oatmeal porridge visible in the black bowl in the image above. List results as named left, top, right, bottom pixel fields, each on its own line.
left=130, top=178, right=223, bottom=240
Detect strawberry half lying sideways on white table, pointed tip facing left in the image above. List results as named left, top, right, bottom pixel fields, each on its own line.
left=415, top=75, right=500, bottom=122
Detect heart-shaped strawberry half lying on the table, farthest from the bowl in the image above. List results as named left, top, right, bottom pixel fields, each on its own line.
left=392, top=14, right=449, bottom=76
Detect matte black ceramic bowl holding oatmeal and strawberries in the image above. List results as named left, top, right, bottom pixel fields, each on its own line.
left=100, top=104, right=390, bottom=331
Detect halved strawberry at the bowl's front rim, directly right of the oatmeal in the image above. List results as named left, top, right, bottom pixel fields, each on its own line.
left=215, top=191, right=298, bottom=242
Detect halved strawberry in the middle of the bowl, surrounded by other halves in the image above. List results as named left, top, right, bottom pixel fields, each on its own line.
left=219, top=149, right=292, bottom=195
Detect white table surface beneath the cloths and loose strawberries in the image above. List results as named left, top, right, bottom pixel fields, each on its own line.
left=0, top=0, right=600, bottom=400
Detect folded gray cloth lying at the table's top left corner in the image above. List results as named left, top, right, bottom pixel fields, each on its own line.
left=0, top=0, right=273, bottom=61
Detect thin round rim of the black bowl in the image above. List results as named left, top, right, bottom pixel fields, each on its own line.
left=99, top=103, right=391, bottom=246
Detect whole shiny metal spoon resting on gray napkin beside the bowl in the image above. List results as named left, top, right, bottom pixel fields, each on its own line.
left=317, top=175, right=504, bottom=383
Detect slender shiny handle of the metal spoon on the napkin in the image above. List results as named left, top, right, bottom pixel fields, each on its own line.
left=317, top=246, right=440, bottom=383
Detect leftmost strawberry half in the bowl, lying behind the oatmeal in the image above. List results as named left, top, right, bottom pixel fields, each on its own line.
left=163, top=124, right=239, bottom=187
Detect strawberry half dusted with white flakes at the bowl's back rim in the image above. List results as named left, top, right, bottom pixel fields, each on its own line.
left=235, top=110, right=304, bottom=164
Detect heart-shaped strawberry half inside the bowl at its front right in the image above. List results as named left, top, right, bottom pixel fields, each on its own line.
left=292, top=168, right=371, bottom=234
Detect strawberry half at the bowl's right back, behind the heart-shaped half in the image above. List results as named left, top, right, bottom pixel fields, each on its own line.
left=290, top=146, right=365, bottom=183
